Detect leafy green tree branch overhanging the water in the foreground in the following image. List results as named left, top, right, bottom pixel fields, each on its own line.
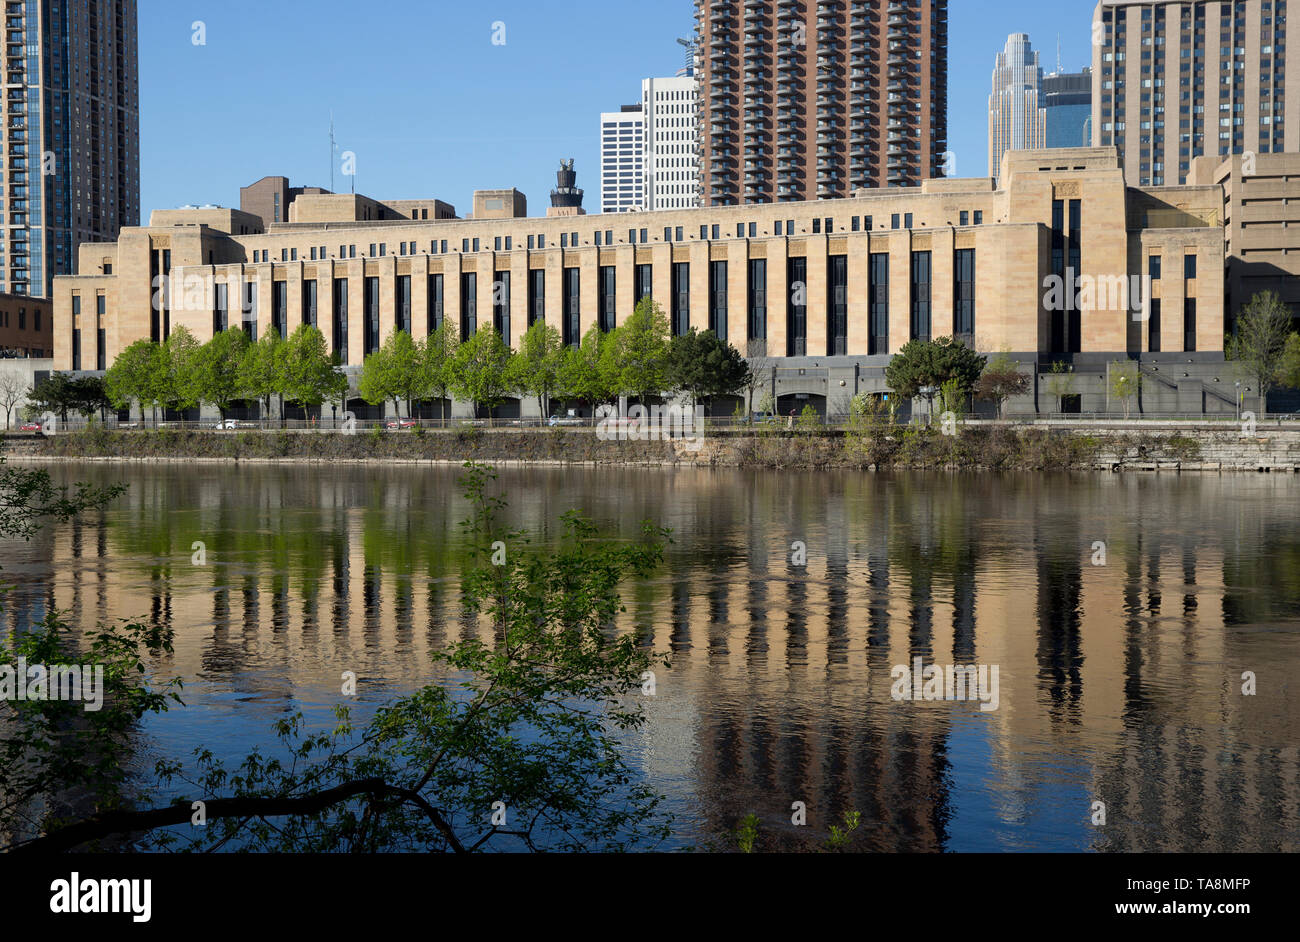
left=0, top=463, right=670, bottom=852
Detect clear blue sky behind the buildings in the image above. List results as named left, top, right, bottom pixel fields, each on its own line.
left=139, top=0, right=1093, bottom=216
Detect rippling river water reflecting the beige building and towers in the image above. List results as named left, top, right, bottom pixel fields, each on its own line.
left=0, top=464, right=1300, bottom=851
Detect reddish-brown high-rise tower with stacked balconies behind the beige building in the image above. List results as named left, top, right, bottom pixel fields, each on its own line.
left=696, top=0, right=948, bottom=205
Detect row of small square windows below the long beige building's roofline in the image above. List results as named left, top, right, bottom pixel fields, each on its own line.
left=233, top=209, right=984, bottom=262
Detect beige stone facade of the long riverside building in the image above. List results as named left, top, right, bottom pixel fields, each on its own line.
left=55, top=148, right=1223, bottom=369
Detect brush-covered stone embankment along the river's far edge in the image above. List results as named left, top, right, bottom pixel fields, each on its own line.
left=3, top=421, right=1300, bottom=472
